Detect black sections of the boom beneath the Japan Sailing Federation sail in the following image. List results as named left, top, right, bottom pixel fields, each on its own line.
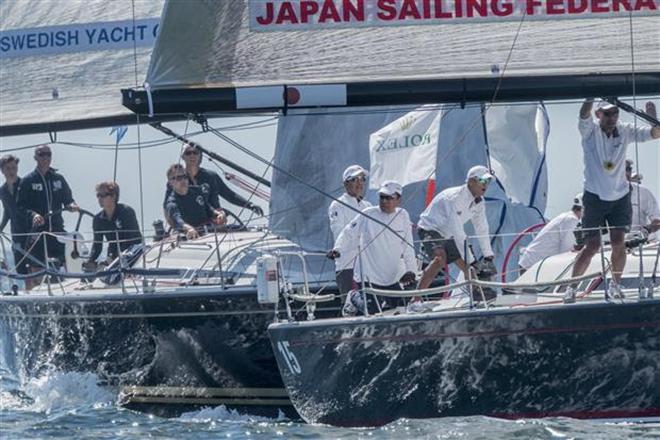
left=122, top=72, right=660, bottom=115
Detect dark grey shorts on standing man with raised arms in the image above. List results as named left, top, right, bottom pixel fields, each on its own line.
left=582, top=191, right=632, bottom=238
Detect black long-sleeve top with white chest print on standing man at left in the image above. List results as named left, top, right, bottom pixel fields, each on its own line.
left=16, top=168, right=73, bottom=232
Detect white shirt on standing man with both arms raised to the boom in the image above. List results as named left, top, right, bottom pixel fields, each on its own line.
left=578, top=116, right=652, bottom=201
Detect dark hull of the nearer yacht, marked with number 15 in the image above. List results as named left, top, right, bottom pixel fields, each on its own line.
left=269, top=300, right=660, bottom=426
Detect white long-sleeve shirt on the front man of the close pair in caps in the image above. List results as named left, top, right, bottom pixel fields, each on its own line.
left=335, top=206, right=417, bottom=286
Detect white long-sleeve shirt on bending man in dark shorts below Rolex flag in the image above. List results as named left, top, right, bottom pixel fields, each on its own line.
left=418, top=184, right=493, bottom=259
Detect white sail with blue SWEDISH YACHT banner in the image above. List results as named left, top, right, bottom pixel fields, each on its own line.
left=0, top=0, right=164, bottom=135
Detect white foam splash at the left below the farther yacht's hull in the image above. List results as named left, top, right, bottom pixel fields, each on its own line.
left=23, top=372, right=116, bottom=414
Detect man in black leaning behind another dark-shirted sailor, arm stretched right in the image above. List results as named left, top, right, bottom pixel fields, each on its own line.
left=165, top=143, right=264, bottom=217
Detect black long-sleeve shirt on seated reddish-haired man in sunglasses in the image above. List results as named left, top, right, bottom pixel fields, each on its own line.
left=89, top=203, right=142, bottom=261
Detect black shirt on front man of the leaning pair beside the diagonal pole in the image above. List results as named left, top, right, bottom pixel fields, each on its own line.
left=165, top=186, right=214, bottom=231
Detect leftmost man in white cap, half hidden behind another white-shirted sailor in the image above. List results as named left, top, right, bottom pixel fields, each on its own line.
left=328, top=165, right=371, bottom=295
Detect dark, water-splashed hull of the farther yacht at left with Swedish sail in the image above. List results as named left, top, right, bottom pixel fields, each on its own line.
left=0, top=289, right=338, bottom=415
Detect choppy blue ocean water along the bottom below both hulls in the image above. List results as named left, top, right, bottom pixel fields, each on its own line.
left=0, top=370, right=660, bottom=440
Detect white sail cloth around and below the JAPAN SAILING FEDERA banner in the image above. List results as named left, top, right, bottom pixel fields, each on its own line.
left=147, top=0, right=660, bottom=91
